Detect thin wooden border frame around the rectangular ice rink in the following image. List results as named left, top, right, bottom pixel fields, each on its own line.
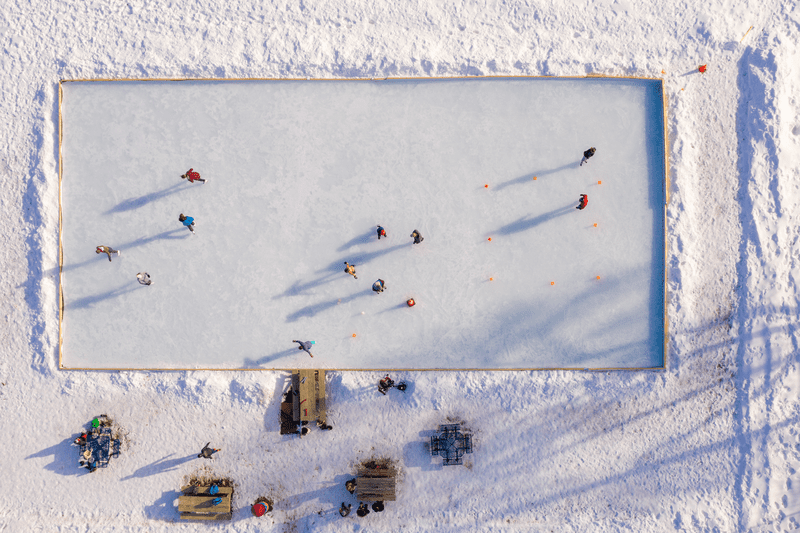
left=58, top=74, right=670, bottom=372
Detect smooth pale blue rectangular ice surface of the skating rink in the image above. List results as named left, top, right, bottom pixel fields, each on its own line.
left=61, top=78, right=665, bottom=369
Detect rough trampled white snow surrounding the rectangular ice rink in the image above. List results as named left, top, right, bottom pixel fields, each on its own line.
left=0, top=0, right=800, bottom=532
